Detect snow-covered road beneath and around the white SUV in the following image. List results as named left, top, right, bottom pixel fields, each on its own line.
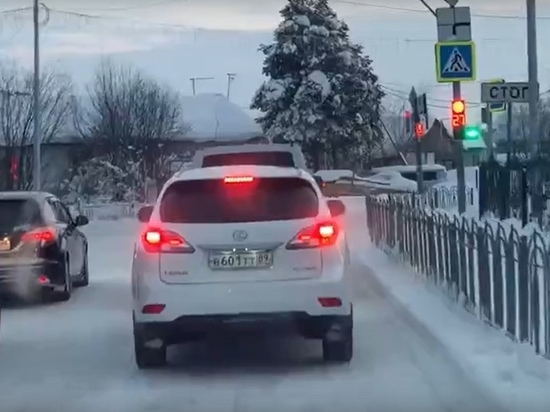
left=0, top=214, right=497, bottom=412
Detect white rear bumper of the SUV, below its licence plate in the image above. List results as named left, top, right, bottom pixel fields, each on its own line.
left=133, top=276, right=351, bottom=322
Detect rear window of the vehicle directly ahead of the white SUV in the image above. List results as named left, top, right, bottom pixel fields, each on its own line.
left=202, top=152, right=295, bottom=167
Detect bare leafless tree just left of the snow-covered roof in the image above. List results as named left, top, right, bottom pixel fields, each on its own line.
left=79, top=60, right=187, bottom=193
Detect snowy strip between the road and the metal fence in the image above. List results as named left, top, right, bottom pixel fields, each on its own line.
left=355, top=244, right=550, bottom=412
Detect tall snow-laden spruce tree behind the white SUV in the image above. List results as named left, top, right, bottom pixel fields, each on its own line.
left=251, top=0, right=383, bottom=169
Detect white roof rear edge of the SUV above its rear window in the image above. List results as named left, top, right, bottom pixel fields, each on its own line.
left=171, top=165, right=313, bottom=181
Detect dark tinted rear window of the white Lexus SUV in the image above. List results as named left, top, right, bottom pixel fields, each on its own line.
left=160, top=178, right=319, bottom=223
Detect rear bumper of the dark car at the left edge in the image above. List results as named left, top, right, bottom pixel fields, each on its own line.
left=0, top=260, right=64, bottom=293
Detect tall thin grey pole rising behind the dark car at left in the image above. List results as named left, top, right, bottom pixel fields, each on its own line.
left=33, top=0, right=42, bottom=191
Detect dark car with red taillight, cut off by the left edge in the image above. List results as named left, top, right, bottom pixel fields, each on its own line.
left=0, top=192, right=89, bottom=301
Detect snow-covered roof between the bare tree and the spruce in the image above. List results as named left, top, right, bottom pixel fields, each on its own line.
left=182, top=94, right=262, bottom=142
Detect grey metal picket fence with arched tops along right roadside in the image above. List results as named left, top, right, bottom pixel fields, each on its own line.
left=366, top=196, right=550, bottom=356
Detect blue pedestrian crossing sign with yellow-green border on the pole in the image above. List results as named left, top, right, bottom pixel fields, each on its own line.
left=435, top=41, right=476, bottom=83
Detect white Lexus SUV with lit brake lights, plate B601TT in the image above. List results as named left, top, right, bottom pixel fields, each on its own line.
left=132, top=166, right=353, bottom=368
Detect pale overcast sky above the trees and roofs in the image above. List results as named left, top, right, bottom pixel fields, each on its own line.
left=0, top=0, right=550, bottom=122
